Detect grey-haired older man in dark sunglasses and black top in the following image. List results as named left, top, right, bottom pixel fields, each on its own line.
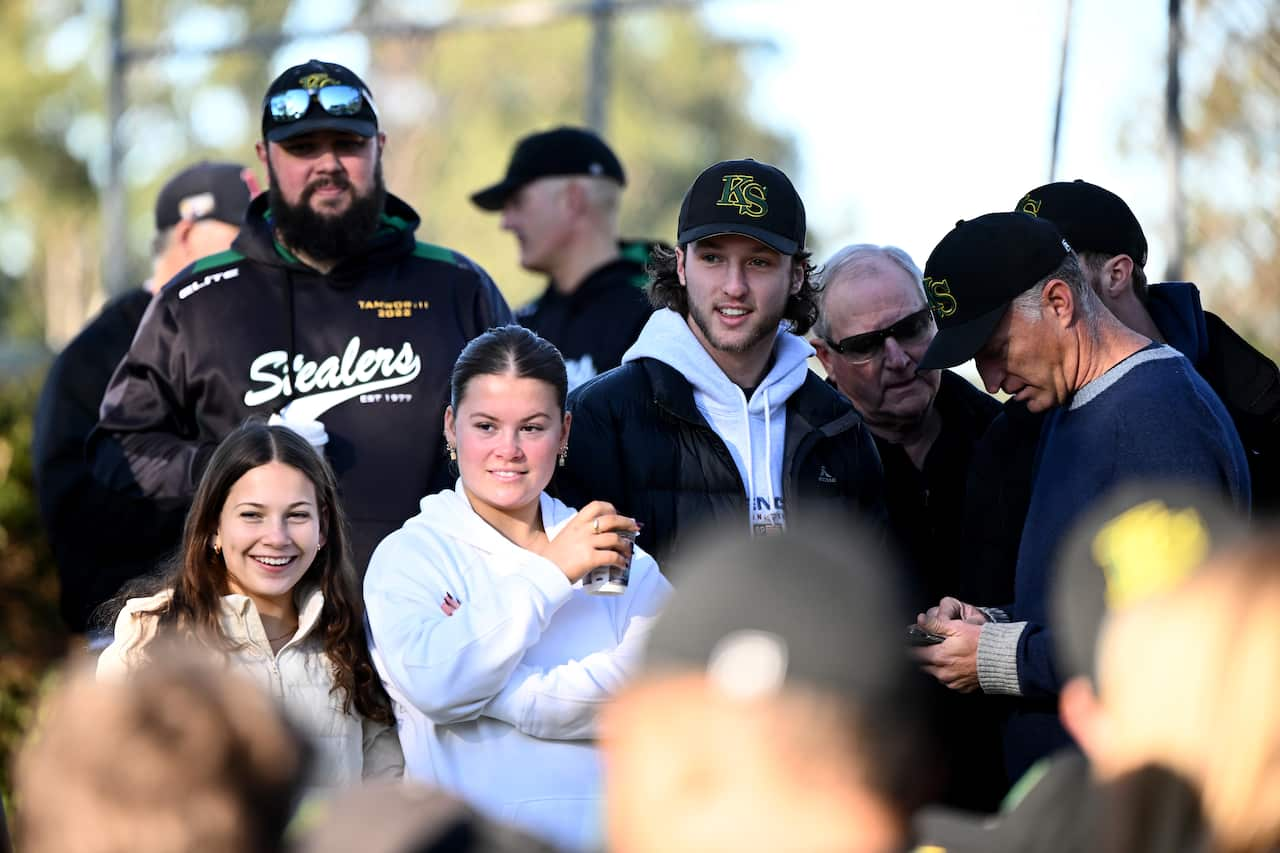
left=813, top=243, right=1012, bottom=811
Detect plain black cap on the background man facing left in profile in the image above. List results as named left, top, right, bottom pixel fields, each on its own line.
left=471, top=127, right=627, bottom=210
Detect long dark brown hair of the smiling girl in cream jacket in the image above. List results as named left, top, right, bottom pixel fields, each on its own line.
left=116, top=418, right=396, bottom=725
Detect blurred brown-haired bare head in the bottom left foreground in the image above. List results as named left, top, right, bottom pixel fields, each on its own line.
left=15, top=649, right=307, bottom=853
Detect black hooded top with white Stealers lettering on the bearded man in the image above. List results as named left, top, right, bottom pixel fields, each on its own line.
left=91, top=193, right=511, bottom=570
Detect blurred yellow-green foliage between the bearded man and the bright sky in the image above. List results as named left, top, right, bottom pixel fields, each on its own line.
left=371, top=0, right=794, bottom=305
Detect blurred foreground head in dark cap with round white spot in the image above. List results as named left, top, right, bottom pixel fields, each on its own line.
left=602, top=520, right=932, bottom=853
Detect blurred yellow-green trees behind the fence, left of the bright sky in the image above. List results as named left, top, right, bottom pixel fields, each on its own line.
left=0, top=0, right=791, bottom=347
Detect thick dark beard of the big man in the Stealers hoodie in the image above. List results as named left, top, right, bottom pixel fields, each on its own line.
left=266, top=161, right=387, bottom=261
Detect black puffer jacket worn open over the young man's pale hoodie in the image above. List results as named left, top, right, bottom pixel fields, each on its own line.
left=554, top=350, right=884, bottom=578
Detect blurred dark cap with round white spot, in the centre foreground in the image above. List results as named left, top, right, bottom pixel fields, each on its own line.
left=645, top=517, right=928, bottom=713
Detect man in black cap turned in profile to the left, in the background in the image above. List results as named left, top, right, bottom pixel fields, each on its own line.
left=471, top=127, right=653, bottom=389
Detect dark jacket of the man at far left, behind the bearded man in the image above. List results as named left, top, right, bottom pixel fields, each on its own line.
left=32, top=288, right=182, bottom=633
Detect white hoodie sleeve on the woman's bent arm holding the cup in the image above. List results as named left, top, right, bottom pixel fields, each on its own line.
left=365, top=529, right=572, bottom=725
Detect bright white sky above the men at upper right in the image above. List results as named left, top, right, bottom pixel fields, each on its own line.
left=704, top=0, right=1194, bottom=274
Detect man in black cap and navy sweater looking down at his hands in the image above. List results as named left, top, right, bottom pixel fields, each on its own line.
left=918, top=213, right=1249, bottom=779
